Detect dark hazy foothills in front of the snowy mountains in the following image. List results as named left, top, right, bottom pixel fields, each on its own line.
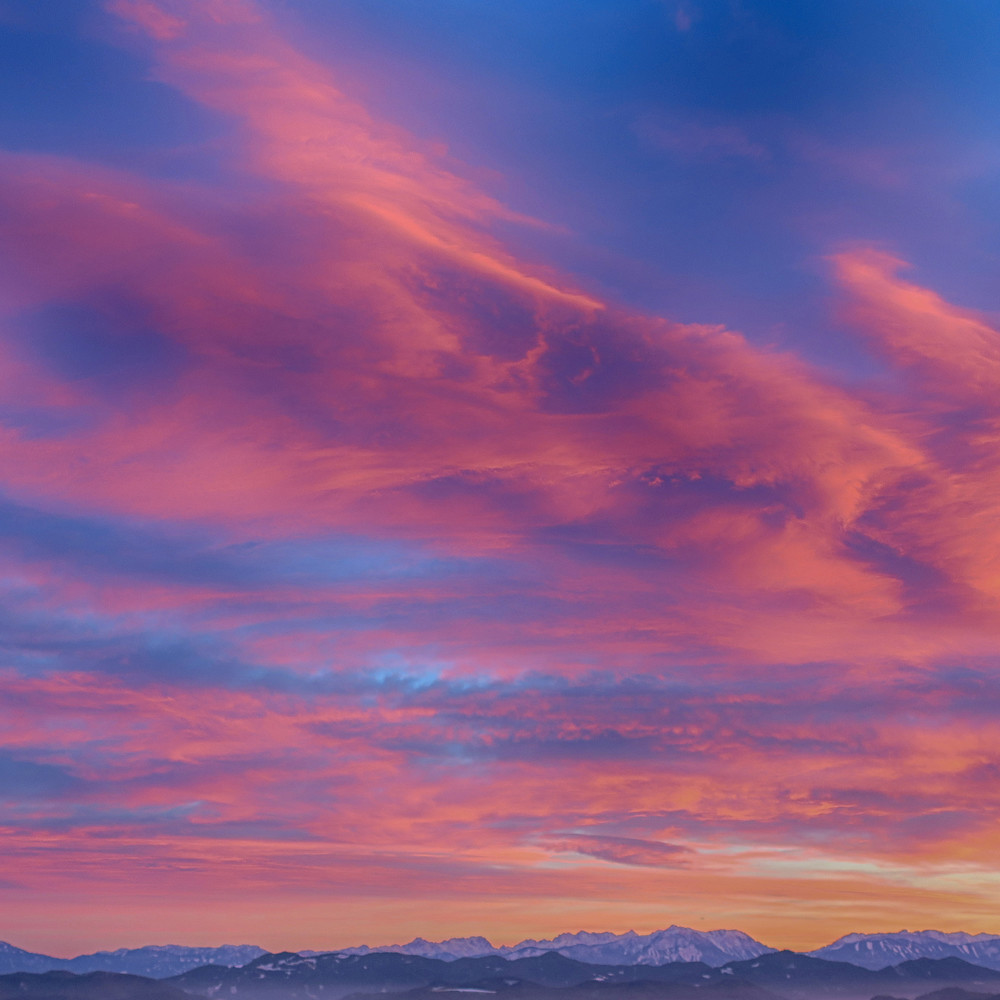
left=9, top=951, right=1000, bottom=1000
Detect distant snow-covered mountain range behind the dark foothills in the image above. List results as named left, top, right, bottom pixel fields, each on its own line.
left=0, top=925, right=1000, bottom=979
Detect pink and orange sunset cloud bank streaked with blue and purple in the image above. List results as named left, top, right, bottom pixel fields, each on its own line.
left=0, top=0, right=1000, bottom=947
